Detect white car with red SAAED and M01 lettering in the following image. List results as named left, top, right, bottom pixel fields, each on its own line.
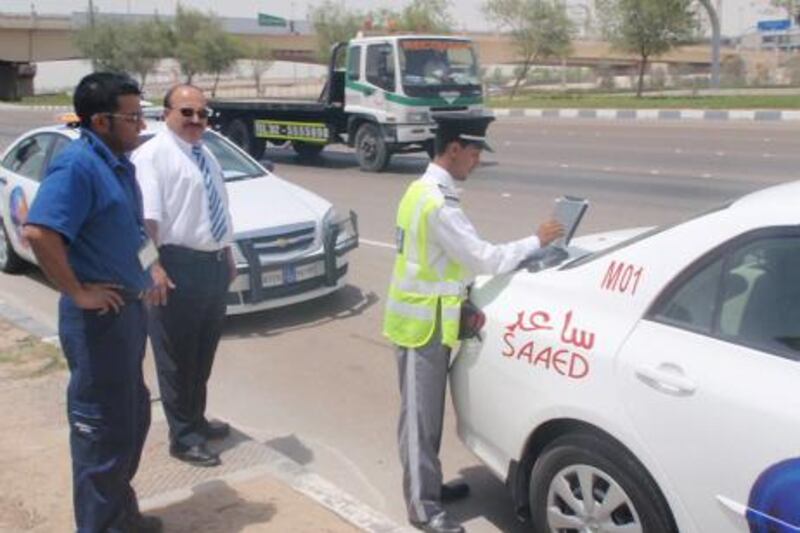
left=450, top=182, right=800, bottom=533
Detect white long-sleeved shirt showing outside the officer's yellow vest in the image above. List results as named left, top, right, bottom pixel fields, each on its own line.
left=420, top=163, right=540, bottom=276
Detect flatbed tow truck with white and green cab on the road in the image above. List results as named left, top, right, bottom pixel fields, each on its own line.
left=209, top=34, right=485, bottom=172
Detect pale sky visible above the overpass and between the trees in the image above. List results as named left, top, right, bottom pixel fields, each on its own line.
left=0, top=0, right=782, bottom=36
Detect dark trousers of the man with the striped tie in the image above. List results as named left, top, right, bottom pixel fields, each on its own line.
left=149, top=246, right=230, bottom=446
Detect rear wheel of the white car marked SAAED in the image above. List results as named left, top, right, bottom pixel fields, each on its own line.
left=528, top=433, right=677, bottom=533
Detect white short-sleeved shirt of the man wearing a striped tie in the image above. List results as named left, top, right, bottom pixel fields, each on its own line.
left=131, top=128, right=233, bottom=251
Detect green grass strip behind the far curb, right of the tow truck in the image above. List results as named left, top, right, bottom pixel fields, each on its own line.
left=489, top=93, right=800, bottom=109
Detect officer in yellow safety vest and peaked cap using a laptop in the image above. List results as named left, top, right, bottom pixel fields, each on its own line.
left=383, top=114, right=563, bottom=533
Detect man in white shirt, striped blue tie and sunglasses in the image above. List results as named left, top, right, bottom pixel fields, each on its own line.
left=131, top=85, right=236, bottom=466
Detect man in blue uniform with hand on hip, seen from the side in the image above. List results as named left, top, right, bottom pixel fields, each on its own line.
left=25, top=72, right=161, bottom=533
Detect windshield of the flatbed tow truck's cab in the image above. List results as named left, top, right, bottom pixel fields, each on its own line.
left=400, top=39, right=480, bottom=88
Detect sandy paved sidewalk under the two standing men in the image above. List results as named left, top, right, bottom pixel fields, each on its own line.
left=0, top=318, right=401, bottom=533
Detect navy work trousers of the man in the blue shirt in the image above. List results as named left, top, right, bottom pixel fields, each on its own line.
left=59, top=297, right=150, bottom=533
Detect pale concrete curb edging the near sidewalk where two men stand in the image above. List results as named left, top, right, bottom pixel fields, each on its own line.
left=0, top=300, right=406, bottom=533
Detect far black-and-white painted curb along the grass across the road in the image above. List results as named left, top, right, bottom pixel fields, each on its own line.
left=492, top=108, right=800, bottom=122
